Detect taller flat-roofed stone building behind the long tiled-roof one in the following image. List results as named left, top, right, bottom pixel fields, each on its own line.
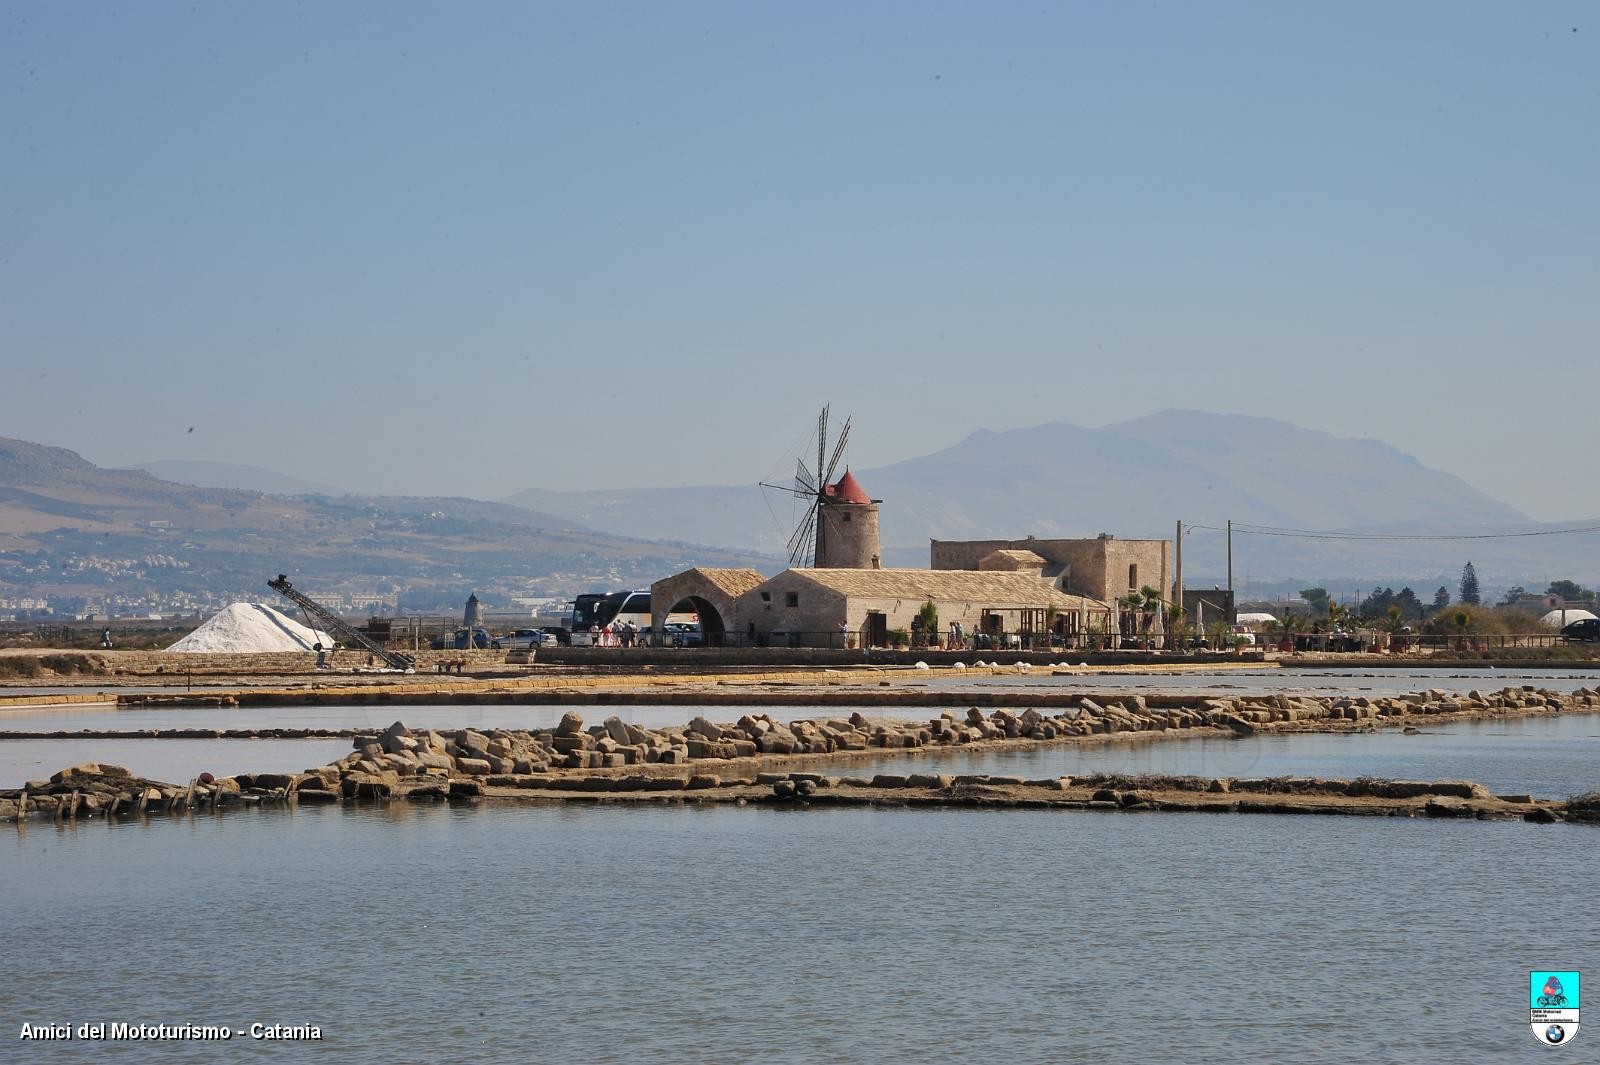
left=928, top=533, right=1173, bottom=603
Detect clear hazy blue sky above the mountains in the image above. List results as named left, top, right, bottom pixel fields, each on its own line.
left=0, top=0, right=1600, bottom=520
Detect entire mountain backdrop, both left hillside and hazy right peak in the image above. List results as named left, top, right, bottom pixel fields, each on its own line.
left=0, top=411, right=1600, bottom=609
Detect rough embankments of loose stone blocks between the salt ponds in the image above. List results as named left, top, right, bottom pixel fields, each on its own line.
left=9, top=688, right=1600, bottom=820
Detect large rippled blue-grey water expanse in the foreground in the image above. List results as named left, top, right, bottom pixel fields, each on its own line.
left=0, top=803, right=1600, bottom=1065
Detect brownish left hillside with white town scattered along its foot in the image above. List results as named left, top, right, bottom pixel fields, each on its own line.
left=0, top=438, right=779, bottom=612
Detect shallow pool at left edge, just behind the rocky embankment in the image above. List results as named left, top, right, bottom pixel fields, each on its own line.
left=0, top=739, right=350, bottom=788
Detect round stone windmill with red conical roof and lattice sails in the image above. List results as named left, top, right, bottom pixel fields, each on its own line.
left=762, top=406, right=883, bottom=569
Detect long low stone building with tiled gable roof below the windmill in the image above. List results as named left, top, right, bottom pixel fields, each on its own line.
left=738, top=569, right=1112, bottom=648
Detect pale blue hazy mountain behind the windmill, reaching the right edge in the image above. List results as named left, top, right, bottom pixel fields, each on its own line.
left=507, top=411, right=1600, bottom=585
